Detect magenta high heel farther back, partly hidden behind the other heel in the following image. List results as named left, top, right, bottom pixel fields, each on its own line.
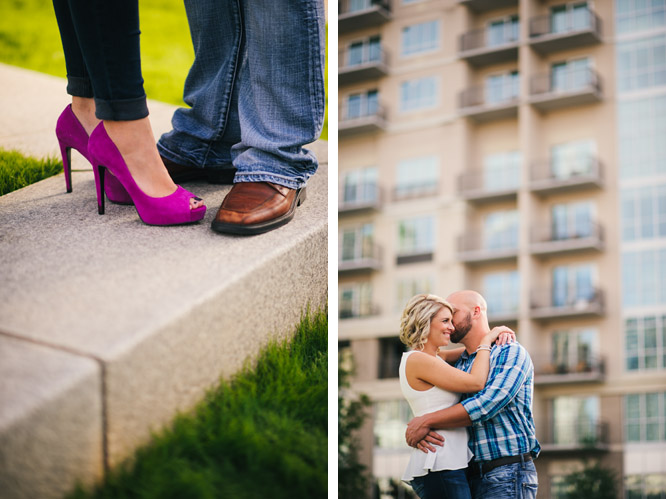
left=56, top=104, right=132, bottom=204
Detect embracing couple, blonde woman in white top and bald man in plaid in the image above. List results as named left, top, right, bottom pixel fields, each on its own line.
left=400, top=291, right=540, bottom=499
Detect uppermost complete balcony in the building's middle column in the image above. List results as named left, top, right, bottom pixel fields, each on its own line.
left=458, top=25, right=520, bottom=67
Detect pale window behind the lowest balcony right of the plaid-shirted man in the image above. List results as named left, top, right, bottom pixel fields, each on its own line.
left=552, top=396, right=601, bottom=446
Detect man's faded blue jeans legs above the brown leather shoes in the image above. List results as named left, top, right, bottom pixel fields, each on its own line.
left=158, top=0, right=325, bottom=189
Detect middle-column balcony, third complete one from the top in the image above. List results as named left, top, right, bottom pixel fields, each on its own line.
left=458, top=170, right=520, bottom=204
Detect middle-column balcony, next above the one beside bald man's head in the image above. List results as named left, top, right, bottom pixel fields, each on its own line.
left=458, top=231, right=518, bottom=264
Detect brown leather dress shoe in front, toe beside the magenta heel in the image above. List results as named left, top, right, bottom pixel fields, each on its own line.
left=211, top=182, right=305, bottom=235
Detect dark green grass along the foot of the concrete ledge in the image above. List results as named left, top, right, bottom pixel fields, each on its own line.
left=69, top=312, right=328, bottom=499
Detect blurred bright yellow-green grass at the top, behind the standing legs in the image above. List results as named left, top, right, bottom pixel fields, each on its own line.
left=0, top=0, right=328, bottom=139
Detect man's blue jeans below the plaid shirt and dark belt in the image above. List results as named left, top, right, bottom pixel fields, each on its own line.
left=469, top=461, right=539, bottom=499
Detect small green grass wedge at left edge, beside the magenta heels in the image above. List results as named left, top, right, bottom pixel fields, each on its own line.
left=0, top=148, right=64, bottom=196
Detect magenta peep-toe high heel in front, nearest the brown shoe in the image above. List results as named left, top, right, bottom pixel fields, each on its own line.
left=88, top=123, right=206, bottom=225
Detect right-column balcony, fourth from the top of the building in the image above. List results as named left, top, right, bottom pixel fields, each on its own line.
left=530, top=221, right=604, bottom=257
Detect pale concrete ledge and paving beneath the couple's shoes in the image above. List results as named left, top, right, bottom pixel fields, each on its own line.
left=0, top=65, right=328, bottom=498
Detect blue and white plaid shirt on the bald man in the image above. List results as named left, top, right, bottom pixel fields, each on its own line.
left=456, top=342, right=541, bottom=461
